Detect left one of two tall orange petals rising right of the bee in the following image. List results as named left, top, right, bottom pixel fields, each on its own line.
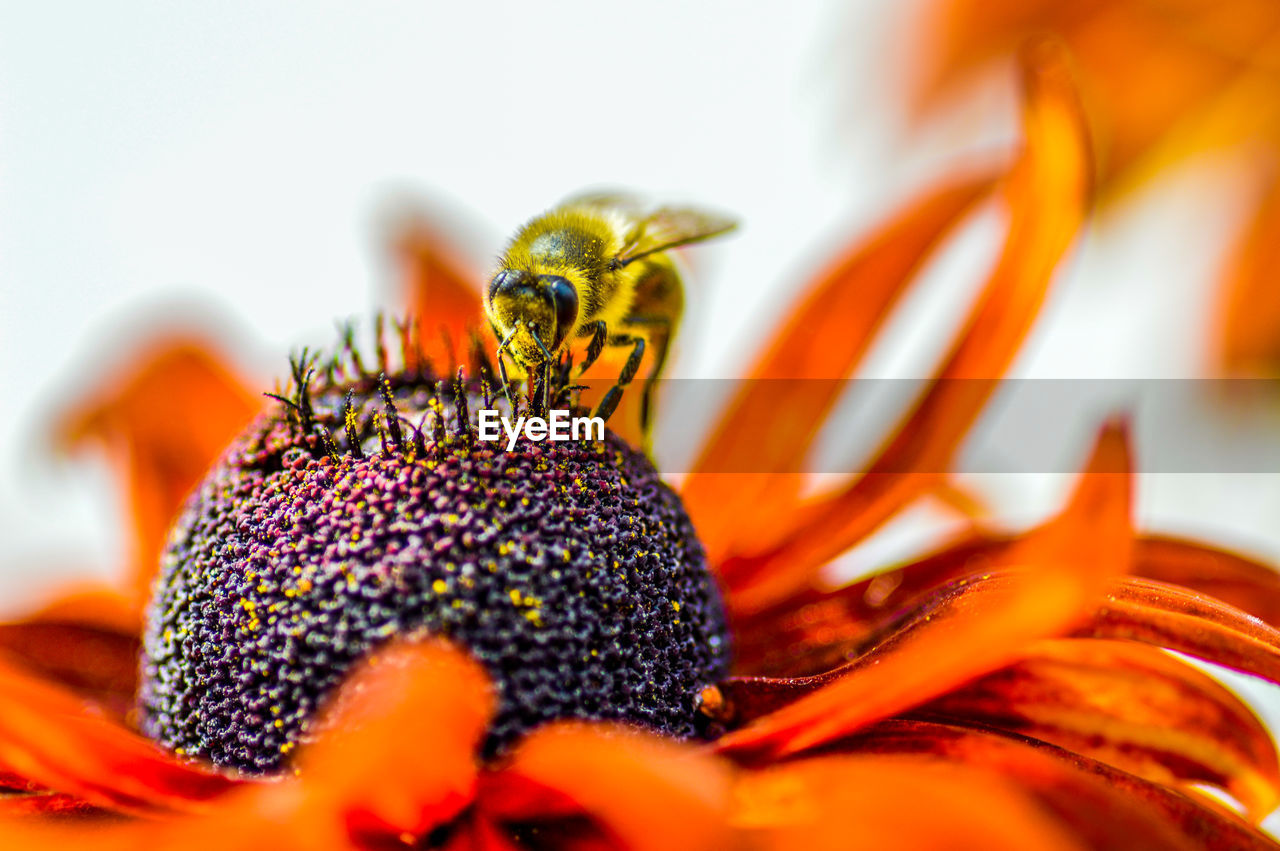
left=681, top=174, right=993, bottom=561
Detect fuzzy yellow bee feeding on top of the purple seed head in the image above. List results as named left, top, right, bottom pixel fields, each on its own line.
left=484, top=195, right=737, bottom=440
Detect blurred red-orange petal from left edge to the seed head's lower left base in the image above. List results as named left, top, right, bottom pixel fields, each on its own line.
left=0, top=652, right=234, bottom=810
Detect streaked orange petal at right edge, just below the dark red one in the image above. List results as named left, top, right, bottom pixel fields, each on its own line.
left=1075, top=570, right=1280, bottom=683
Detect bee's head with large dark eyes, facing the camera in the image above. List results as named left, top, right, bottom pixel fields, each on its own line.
left=488, top=269, right=577, bottom=363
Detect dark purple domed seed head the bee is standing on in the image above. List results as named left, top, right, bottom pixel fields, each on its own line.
left=140, top=355, right=728, bottom=773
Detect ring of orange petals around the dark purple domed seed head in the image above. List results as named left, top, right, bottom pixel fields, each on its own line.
left=0, top=44, right=1280, bottom=850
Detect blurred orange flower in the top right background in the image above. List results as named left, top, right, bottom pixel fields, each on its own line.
left=915, top=0, right=1280, bottom=376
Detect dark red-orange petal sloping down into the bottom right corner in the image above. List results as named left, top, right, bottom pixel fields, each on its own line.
left=840, top=720, right=1276, bottom=851
